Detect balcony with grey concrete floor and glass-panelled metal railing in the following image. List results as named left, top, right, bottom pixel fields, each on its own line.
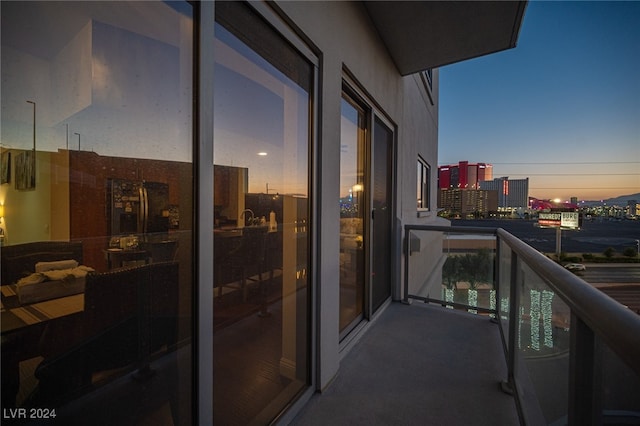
left=293, top=225, right=640, bottom=426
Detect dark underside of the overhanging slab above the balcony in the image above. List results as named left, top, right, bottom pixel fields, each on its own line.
left=364, top=0, right=527, bottom=75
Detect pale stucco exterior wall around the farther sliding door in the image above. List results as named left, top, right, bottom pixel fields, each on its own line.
left=278, top=1, right=441, bottom=388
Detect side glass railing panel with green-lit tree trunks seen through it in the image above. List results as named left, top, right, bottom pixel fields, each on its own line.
left=515, top=264, right=571, bottom=424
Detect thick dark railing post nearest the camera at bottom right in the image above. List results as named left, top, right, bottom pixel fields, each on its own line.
left=568, top=311, right=602, bottom=426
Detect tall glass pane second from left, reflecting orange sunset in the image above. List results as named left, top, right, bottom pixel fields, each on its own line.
left=213, top=3, right=311, bottom=424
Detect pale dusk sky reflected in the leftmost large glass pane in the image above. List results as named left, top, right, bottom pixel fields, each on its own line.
left=1, top=2, right=192, bottom=161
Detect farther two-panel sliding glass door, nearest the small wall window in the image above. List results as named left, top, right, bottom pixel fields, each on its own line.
left=339, top=87, right=394, bottom=339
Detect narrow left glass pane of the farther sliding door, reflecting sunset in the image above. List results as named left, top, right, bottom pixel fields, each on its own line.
left=340, top=95, right=366, bottom=333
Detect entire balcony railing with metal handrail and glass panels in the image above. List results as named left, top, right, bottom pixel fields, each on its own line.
left=404, top=225, right=640, bottom=426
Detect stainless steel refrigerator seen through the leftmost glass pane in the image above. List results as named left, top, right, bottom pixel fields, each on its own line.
left=107, top=179, right=169, bottom=241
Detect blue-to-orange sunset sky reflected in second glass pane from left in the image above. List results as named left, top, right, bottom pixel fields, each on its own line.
left=214, top=25, right=310, bottom=196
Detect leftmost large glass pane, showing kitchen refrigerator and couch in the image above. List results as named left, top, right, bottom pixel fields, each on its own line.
left=0, top=2, right=193, bottom=424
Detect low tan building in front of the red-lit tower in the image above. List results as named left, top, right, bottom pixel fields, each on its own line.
left=438, top=188, right=498, bottom=217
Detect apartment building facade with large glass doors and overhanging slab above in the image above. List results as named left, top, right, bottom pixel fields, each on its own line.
left=0, top=1, right=526, bottom=424
